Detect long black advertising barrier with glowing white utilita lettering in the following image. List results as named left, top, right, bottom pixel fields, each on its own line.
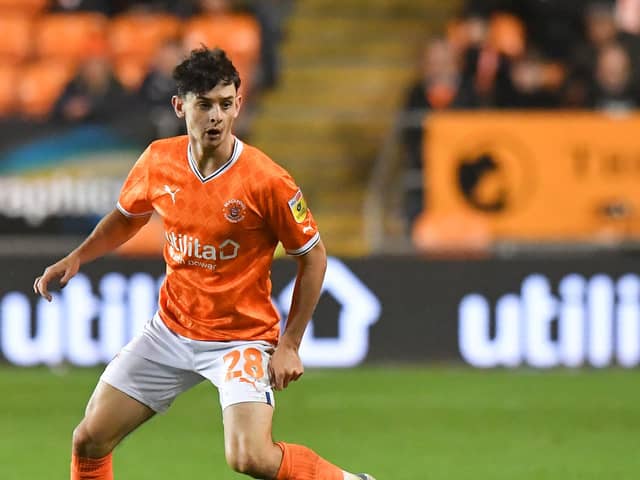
left=0, top=255, right=640, bottom=368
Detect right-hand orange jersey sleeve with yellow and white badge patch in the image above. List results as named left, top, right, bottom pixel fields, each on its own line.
left=267, top=174, right=320, bottom=255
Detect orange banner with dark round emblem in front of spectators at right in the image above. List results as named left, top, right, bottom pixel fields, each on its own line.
left=416, top=112, right=640, bottom=248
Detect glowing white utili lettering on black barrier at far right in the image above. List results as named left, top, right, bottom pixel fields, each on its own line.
left=458, top=274, right=640, bottom=368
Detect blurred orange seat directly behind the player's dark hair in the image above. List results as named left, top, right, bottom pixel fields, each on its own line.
left=183, top=14, right=260, bottom=93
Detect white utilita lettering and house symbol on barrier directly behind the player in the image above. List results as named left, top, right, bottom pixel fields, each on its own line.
left=0, top=258, right=381, bottom=367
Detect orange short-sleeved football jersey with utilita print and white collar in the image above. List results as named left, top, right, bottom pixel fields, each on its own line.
left=118, top=136, right=320, bottom=343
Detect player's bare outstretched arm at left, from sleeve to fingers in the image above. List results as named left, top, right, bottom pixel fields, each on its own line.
left=33, top=209, right=151, bottom=301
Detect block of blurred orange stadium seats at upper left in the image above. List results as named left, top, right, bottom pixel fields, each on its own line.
left=0, top=0, right=261, bottom=120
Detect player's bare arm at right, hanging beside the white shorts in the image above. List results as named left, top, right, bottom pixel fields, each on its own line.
left=269, top=240, right=327, bottom=390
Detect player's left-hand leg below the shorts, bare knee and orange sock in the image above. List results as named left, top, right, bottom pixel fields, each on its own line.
left=71, top=381, right=155, bottom=480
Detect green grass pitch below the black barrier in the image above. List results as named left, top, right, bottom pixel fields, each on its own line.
left=0, top=367, right=640, bottom=480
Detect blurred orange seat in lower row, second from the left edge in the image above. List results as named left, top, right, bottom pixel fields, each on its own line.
left=17, top=60, right=75, bottom=118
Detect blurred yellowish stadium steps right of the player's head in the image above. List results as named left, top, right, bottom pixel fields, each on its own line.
left=250, top=0, right=459, bottom=256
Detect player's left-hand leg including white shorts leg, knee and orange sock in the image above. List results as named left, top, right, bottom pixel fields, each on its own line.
left=71, top=317, right=204, bottom=480
